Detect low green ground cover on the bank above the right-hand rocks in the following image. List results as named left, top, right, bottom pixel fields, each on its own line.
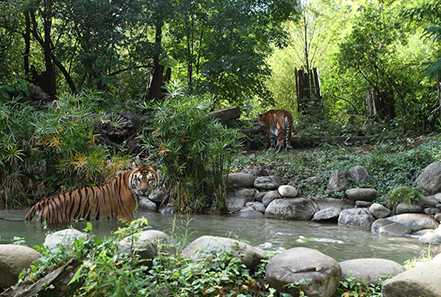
left=232, top=138, right=434, bottom=202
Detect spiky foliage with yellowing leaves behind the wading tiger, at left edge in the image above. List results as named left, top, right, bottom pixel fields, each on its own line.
left=0, top=88, right=129, bottom=207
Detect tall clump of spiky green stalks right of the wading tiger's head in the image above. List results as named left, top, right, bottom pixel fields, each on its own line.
left=142, top=82, right=238, bottom=212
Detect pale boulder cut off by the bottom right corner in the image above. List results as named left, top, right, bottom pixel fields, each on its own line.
left=381, top=261, right=441, bottom=297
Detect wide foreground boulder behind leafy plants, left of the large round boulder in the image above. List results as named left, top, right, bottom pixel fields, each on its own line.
left=182, top=236, right=266, bottom=270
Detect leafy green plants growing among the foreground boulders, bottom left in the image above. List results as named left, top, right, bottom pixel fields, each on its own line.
left=20, top=219, right=274, bottom=297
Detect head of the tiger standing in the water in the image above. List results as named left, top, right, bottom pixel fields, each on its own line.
left=130, top=165, right=159, bottom=199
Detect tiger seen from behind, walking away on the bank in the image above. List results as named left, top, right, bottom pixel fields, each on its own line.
left=257, top=109, right=293, bottom=153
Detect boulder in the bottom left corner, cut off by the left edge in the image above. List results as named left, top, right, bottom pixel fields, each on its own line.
left=0, top=244, right=41, bottom=289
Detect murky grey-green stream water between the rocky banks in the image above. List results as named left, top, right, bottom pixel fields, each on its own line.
left=0, top=209, right=441, bottom=264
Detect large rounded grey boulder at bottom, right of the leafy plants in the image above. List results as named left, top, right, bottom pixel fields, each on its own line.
left=266, top=247, right=341, bottom=297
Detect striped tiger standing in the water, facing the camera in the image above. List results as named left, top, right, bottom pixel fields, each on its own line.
left=24, top=165, right=159, bottom=224
